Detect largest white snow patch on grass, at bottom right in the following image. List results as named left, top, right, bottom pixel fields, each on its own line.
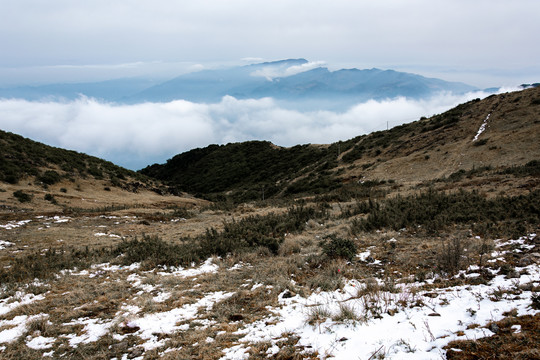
left=222, top=265, right=540, bottom=359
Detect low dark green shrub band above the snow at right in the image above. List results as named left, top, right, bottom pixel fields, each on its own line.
left=352, top=190, right=540, bottom=236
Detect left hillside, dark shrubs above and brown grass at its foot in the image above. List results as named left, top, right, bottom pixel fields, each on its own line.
left=0, top=130, right=202, bottom=213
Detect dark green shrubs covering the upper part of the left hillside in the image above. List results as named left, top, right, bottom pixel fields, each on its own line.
left=0, top=130, right=144, bottom=186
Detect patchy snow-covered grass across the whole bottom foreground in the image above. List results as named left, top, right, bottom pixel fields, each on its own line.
left=0, top=234, right=540, bottom=360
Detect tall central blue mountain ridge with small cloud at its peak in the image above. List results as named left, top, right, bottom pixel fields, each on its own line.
left=126, top=59, right=478, bottom=106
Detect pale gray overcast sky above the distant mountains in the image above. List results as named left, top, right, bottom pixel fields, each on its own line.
left=0, top=0, right=540, bottom=87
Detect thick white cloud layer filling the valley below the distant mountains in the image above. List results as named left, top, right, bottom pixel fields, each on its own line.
left=0, top=93, right=506, bottom=169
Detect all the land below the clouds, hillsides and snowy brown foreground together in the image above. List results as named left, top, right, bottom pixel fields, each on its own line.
left=0, top=89, right=540, bottom=360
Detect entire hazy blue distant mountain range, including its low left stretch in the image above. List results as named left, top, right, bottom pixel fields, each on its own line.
left=0, top=59, right=478, bottom=109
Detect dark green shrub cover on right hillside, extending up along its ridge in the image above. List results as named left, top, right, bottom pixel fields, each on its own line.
left=136, top=93, right=487, bottom=203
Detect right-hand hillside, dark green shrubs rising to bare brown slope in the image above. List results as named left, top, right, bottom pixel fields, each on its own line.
left=141, top=88, right=540, bottom=200
